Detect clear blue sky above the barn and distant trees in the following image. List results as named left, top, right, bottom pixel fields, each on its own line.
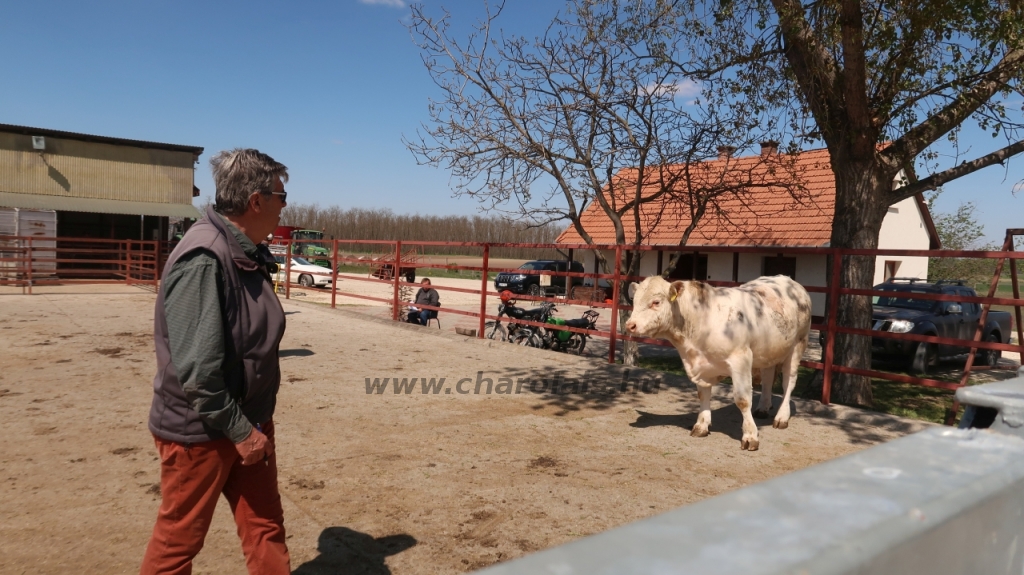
left=0, top=0, right=1024, bottom=240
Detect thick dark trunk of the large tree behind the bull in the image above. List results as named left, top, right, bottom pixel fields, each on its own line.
left=828, top=161, right=892, bottom=405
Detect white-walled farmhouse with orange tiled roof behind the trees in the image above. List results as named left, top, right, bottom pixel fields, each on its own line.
left=558, top=142, right=941, bottom=317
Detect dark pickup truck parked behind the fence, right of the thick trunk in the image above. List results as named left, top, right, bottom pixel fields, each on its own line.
left=871, top=278, right=1012, bottom=373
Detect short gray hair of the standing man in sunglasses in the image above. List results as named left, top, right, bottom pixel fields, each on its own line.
left=210, top=147, right=288, bottom=216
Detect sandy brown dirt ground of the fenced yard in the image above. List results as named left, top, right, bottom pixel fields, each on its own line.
left=0, top=286, right=923, bottom=574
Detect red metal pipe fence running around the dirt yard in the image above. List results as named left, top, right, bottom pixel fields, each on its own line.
left=0, top=230, right=1024, bottom=411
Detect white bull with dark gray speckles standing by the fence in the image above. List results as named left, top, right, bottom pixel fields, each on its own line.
left=626, top=275, right=811, bottom=451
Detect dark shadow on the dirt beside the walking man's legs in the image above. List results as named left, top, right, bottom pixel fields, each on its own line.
left=292, top=527, right=417, bottom=575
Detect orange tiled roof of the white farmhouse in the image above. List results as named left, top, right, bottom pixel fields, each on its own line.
left=557, top=149, right=836, bottom=247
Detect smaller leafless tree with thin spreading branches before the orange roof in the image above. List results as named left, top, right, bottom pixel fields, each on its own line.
left=407, top=0, right=792, bottom=364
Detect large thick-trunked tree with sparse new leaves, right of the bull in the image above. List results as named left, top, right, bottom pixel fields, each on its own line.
left=626, top=0, right=1024, bottom=404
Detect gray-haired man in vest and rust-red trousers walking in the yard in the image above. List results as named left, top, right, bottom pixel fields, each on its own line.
left=141, top=149, right=291, bottom=574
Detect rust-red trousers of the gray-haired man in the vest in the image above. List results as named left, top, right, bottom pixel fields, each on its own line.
left=141, top=422, right=291, bottom=575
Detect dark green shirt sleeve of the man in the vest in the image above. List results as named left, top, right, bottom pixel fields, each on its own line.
left=162, top=250, right=252, bottom=443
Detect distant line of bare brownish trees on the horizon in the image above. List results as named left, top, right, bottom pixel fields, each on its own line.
left=281, top=204, right=569, bottom=255
